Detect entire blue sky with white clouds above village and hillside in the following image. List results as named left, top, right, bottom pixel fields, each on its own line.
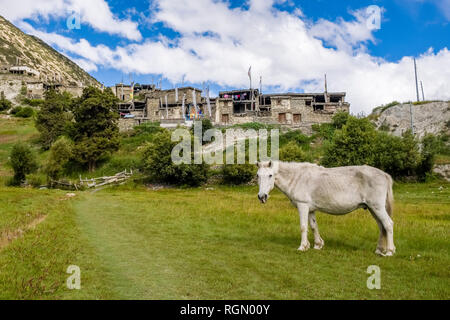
left=0, top=0, right=450, bottom=113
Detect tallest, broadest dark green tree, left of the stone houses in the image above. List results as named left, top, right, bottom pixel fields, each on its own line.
left=69, top=87, right=120, bottom=172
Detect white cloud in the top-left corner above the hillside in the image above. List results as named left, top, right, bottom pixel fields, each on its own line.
left=0, top=0, right=142, bottom=41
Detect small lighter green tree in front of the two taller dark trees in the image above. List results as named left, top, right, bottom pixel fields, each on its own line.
left=44, top=137, right=73, bottom=180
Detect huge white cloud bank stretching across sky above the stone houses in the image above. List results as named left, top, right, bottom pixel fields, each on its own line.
left=3, top=0, right=450, bottom=113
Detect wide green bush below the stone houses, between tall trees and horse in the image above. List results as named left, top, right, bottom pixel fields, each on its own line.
left=142, top=130, right=209, bottom=186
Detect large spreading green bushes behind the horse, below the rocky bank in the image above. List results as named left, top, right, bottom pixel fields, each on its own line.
left=322, top=116, right=438, bottom=179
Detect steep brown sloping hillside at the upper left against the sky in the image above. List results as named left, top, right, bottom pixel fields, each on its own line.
left=0, top=16, right=99, bottom=86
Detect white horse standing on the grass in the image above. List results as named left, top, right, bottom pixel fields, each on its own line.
left=257, top=161, right=395, bottom=256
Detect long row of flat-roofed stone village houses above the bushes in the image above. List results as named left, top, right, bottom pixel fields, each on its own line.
left=113, top=84, right=350, bottom=132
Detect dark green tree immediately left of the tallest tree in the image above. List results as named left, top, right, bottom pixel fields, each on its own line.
left=36, top=90, right=72, bottom=150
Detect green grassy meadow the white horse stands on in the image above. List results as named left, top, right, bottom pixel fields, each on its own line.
left=0, top=119, right=450, bottom=299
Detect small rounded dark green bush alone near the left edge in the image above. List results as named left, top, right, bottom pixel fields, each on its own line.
left=10, top=143, right=37, bottom=185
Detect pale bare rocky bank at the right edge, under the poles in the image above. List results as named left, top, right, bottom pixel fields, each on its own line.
left=370, top=101, right=450, bottom=137
